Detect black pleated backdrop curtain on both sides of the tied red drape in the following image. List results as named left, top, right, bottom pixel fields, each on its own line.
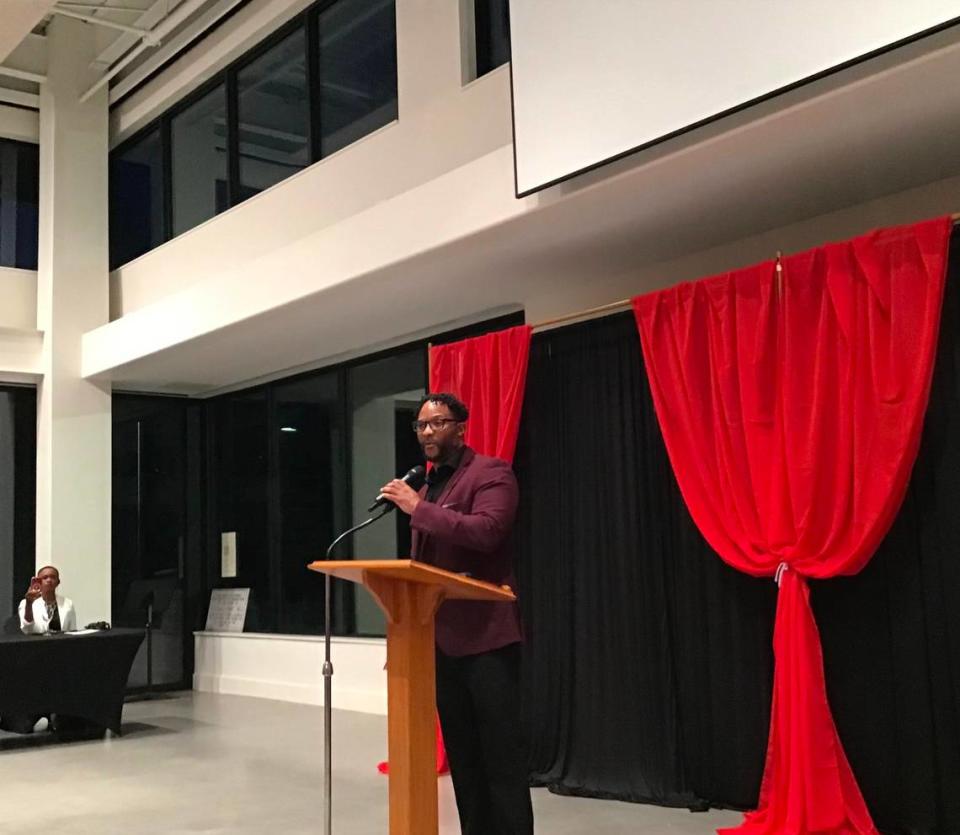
left=516, top=234, right=960, bottom=835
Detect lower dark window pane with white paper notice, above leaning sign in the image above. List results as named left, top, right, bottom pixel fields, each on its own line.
left=209, top=396, right=276, bottom=632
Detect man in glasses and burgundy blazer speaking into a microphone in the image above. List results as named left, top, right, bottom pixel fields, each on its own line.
left=382, top=394, right=533, bottom=835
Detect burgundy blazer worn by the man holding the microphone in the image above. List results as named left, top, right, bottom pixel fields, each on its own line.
left=410, top=447, right=522, bottom=656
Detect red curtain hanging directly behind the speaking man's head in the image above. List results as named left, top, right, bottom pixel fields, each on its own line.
left=430, top=325, right=533, bottom=463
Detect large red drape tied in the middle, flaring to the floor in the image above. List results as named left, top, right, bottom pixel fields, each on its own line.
left=633, top=218, right=951, bottom=835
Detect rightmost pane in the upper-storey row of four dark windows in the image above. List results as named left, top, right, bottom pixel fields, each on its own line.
left=317, top=0, right=397, bottom=156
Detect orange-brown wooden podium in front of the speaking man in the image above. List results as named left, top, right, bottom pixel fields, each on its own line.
left=308, top=559, right=516, bottom=835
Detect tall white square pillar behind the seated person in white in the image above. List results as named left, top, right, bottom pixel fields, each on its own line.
left=37, top=17, right=111, bottom=625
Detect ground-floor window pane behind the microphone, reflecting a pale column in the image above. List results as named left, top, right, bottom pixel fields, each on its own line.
left=349, top=348, right=426, bottom=635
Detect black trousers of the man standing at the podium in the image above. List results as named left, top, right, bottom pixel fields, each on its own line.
left=437, top=644, right=533, bottom=835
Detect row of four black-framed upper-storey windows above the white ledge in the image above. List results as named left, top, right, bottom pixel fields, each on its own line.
left=107, top=0, right=397, bottom=269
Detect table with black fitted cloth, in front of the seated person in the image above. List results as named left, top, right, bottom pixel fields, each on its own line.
left=0, top=629, right=143, bottom=733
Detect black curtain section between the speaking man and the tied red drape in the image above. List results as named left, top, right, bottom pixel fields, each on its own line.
left=516, top=314, right=776, bottom=807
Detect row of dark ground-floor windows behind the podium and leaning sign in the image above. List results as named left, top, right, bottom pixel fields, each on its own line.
left=190, top=314, right=523, bottom=636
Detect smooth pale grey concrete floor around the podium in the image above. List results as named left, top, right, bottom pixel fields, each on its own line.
left=0, top=693, right=740, bottom=835
